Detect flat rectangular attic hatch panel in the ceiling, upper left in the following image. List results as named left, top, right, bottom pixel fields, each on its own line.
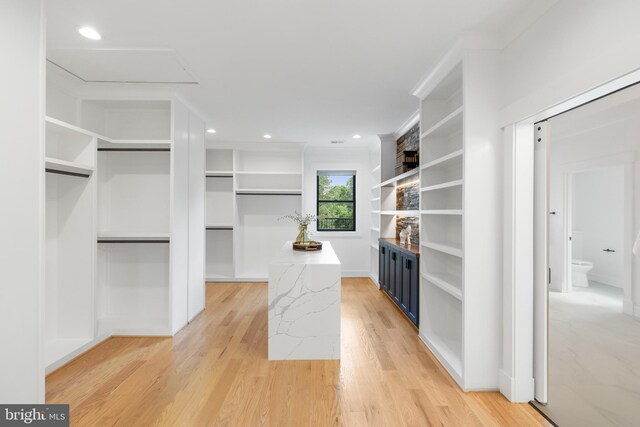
left=47, top=49, right=198, bottom=84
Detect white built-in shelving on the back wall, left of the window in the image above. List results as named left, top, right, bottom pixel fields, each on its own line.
left=205, top=148, right=304, bottom=281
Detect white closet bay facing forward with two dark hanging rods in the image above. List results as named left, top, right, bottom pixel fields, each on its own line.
left=87, top=100, right=176, bottom=335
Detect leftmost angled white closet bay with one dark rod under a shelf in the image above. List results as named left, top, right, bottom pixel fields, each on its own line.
left=43, top=118, right=96, bottom=370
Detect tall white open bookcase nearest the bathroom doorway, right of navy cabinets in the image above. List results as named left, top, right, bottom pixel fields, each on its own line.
left=416, top=51, right=501, bottom=390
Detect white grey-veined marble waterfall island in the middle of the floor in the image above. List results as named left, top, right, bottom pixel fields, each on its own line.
left=268, top=242, right=341, bottom=360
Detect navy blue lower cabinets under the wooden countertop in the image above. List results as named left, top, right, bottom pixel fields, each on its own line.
left=378, top=239, right=420, bottom=326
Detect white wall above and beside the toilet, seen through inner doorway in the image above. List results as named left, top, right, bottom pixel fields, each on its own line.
left=571, top=166, right=631, bottom=288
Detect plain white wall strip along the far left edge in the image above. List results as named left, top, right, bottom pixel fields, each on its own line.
left=0, top=0, right=45, bottom=403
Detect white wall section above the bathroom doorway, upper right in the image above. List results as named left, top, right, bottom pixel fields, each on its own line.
left=501, top=0, right=640, bottom=125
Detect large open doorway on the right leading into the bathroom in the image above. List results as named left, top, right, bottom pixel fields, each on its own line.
left=534, top=85, right=640, bottom=426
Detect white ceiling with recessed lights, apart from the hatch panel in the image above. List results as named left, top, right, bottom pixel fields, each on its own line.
left=47, top=0, right=535, bottom=144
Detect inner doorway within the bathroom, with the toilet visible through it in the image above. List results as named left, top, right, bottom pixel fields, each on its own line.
left=560, top=166, right=632, bottom=311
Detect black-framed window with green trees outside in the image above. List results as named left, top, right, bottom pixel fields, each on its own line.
left=317, top=171, right=356, bottom=231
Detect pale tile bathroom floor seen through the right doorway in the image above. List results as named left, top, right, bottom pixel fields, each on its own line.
left=541, top=282, right=640, bottom=427
